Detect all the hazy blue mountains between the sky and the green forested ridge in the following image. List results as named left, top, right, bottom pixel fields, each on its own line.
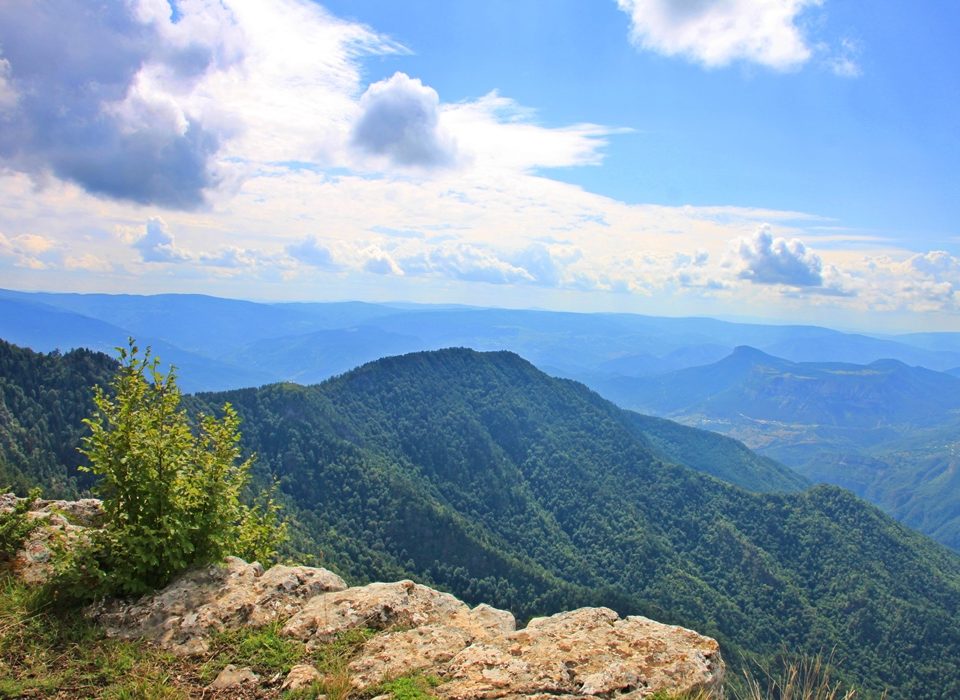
left=0, top=290, right=960, bottom=549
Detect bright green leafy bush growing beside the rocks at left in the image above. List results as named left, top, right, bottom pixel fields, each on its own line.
left=71, top=341, right=284, bottom=595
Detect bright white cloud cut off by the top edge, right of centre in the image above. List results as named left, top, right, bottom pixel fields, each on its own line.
left=617, top=0, right=821, bottom=70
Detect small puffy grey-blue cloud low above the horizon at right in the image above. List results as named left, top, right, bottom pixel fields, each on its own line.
left=733, top=226, right=823, bottom=287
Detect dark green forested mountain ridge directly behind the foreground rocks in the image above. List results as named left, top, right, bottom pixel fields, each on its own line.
left=1, top=340, right=960, bottom=698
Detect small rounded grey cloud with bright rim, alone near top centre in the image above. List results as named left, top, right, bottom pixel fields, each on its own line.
left=352, top=72, right=457, bottom=168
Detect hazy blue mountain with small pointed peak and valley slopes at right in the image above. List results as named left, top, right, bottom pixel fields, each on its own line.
left=595, top=347, right=960, bottom=551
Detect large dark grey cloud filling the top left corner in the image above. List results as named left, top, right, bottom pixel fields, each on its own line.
left=0, top=0, right=218, bottom=208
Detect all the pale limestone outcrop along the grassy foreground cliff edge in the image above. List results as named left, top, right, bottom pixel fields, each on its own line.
left=0, top=499, right=724, bottom=700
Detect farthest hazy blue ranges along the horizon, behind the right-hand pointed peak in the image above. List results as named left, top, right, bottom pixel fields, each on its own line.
left=0, top=290, right=960, bottom=390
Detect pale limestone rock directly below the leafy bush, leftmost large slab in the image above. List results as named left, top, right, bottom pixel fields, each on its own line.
left=88, top=557, right=346, bottom=654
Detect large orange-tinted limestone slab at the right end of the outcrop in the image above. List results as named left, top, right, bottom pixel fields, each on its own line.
left=350, top=608, right=723, bottom=700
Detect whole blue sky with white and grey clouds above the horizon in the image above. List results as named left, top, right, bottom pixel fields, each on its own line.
left=0, top=0, right=960, bottom=332
